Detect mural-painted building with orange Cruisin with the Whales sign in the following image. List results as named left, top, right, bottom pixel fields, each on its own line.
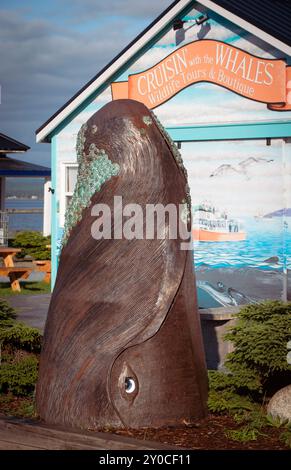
left=36, top=0, right=291, bottom=308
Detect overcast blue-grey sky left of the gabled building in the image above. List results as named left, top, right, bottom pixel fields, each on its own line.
left=0, top=0, right=172, bottom=166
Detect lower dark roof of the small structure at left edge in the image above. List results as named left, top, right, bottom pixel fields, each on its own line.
left=0, top=155, right=51, bottom=178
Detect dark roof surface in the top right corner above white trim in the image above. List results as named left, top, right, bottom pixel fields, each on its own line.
left=213, top=0, right=291, bottom=46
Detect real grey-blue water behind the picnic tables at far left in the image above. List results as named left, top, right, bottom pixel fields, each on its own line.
left=5, top=199, right=43, bottom=235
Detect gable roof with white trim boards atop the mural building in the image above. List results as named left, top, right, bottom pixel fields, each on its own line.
left=36, top=0, right=291, bottom=142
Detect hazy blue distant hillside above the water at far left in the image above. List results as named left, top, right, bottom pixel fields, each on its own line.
left=6, top=178, right=44, bottom=198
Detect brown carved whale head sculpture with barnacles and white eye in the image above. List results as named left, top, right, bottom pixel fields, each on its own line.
left=36, top=100, right=207, bottom=429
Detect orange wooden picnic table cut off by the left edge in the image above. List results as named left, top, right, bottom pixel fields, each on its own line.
left=0, top=247, right=32, bottom=292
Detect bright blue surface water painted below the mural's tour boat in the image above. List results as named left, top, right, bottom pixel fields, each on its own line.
left=194, top=217, right=291, bottom=270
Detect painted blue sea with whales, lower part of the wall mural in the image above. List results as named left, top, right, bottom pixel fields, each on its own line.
left=194, top=217, right=291, bottom=308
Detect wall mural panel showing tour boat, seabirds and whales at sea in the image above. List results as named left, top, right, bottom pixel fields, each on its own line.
left=182, top=140, right=291, bottom=308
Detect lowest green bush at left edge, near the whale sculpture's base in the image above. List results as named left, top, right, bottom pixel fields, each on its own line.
left=0, top=356, right=38, bottom=396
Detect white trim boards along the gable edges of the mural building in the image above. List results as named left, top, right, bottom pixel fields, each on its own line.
left=36, top=0, right=291, bottom=142
